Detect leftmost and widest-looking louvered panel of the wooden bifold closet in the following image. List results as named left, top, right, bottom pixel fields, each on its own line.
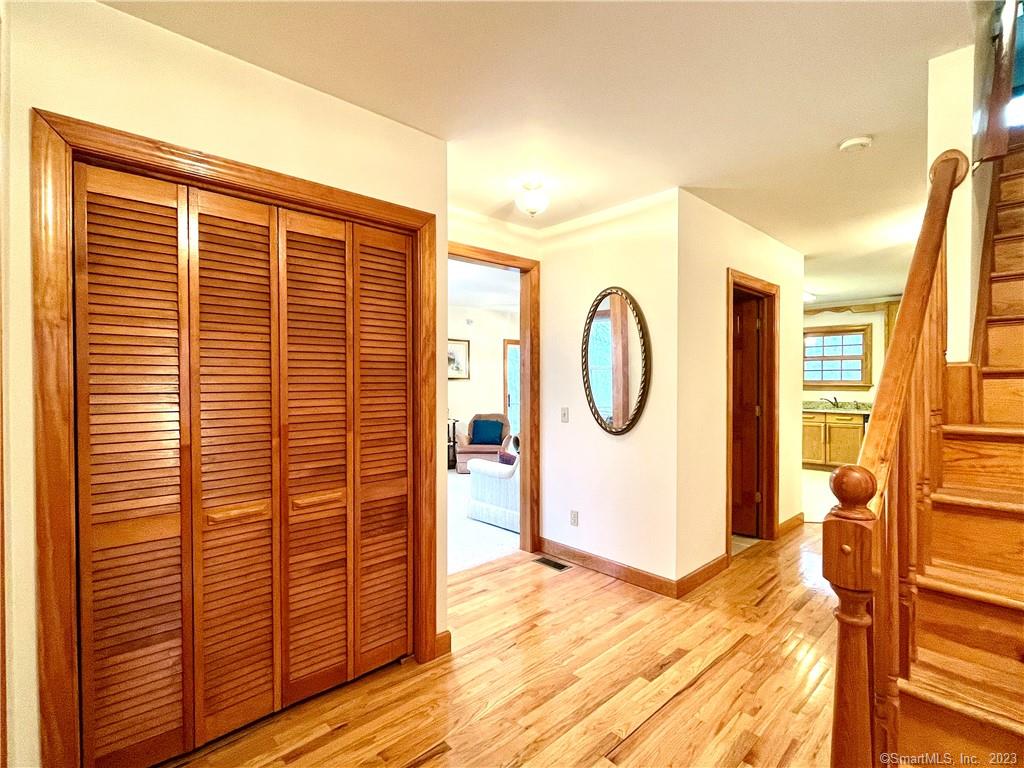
left=69, top=165, right=193, bottom=766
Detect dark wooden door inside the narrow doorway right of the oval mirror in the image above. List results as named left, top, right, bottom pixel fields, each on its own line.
left=732, top=290, right=763, bottom=537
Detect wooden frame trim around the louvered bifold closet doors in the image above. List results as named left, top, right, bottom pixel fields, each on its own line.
left=31, top=110, right=440, bottom=766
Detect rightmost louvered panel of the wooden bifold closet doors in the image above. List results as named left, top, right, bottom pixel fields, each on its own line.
left=352, top=225, right=413, bottom=675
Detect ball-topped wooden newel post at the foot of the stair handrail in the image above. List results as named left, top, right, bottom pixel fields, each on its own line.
left=822, top=464, right=877, bottom=768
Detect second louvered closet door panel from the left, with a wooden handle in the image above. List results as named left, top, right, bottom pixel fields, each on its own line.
left=188, top=189, right=280, bottom=742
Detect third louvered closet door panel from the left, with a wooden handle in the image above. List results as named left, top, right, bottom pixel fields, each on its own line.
left=279, top=210, right=352, bottom=705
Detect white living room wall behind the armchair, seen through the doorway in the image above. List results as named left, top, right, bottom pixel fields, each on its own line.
left=447, top=306, right=519, bottom=434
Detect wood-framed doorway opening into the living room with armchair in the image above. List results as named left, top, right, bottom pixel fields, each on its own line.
left=447, top=243, right=540, bottom=573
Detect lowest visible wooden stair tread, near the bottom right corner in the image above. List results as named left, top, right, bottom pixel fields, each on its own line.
left=900, top=648, right=1024, bottom=735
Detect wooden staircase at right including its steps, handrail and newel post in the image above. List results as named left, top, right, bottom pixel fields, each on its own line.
left=824, top=145, right=1024, bottom=768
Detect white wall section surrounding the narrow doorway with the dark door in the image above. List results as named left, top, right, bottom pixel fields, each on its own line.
left=671, top=190, right=804, bottom=577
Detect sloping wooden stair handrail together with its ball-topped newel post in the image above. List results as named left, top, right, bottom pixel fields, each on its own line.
left=822, top=150, right=970, bottom=768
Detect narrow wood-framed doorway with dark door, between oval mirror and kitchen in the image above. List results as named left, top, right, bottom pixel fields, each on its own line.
left=726, top=269, right=778, bottom=559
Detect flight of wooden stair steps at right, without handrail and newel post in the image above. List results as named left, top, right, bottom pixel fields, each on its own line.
left=897, top=145, right=1024, bottom=764
